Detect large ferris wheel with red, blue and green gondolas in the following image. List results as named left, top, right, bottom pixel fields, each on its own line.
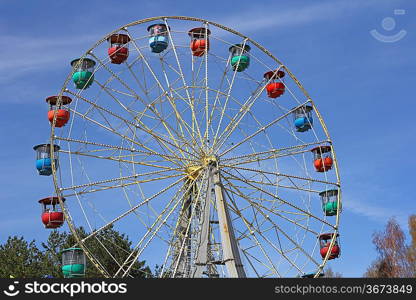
left=35, top=16, right=341, bottom=278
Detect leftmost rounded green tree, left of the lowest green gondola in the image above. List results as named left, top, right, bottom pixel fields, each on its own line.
left=0, top=236, right=44, bottom=278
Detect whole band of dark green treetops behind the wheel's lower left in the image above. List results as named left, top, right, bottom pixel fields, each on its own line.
left=0, top=227, right=153, bottom=278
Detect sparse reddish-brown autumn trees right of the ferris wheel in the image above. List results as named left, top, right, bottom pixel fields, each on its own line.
left=364, top=216, right=416, bottom=278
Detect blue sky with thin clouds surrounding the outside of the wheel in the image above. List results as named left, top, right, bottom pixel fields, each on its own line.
left=0, top=0, right=416, bottom=276
